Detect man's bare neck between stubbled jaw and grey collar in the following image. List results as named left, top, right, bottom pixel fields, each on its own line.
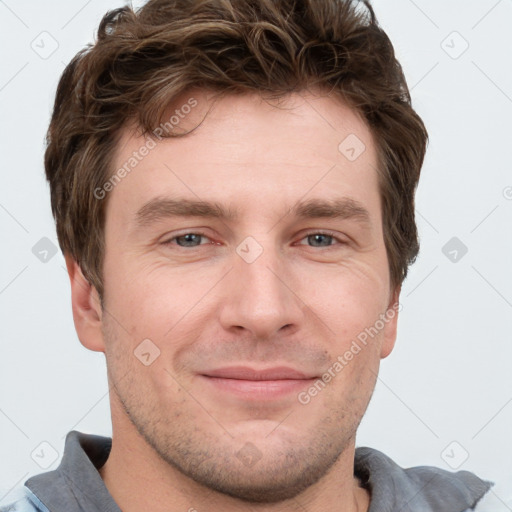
left=99, top=424, right=370, bottom=512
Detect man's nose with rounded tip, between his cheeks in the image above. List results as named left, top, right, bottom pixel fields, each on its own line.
left=220, top=241, right=304, bottom=340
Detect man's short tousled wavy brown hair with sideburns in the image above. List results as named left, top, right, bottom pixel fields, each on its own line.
left=45, top=0, right=428, bottom=297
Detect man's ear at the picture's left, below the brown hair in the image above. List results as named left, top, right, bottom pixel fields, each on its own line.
left=64, top=254, right=105, bottom=352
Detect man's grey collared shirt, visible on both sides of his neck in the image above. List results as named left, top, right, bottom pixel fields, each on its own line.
left=0, top=431, right=492, bottom=512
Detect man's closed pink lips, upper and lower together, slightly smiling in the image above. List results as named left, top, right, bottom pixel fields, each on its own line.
left=201, top=366, right=317, bottom=401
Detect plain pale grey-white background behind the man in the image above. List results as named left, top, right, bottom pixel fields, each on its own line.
left=0, top=0, right=512, bottom=510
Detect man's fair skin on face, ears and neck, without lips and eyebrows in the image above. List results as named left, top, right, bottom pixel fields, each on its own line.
left=67, top=91, right=400, bottom=512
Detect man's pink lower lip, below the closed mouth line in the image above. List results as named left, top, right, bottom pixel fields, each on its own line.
left=202, top=375, right=315, bottom=400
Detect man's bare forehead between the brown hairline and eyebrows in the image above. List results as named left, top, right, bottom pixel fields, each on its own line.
left=108, top=91, right=379, bottom=224
